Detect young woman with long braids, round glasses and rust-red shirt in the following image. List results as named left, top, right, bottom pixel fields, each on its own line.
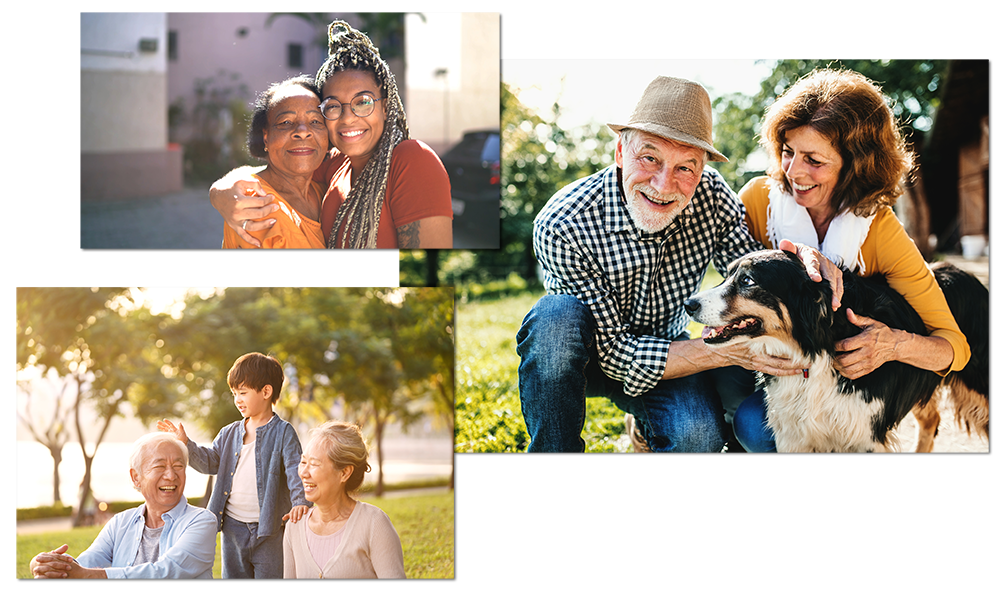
left=209, top=21, right=452, bottom=248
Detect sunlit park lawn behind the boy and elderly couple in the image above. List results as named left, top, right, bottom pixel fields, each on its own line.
left=17, top=492, right=456, bottom=579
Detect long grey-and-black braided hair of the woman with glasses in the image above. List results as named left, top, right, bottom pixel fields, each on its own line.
left=317, top=20, right=410, bottom=248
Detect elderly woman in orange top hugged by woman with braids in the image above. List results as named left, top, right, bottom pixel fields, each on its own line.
left=222, top=76, right=328, bottom=248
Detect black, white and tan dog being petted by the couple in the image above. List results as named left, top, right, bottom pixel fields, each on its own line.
left=685, top=250, right=988, bottom=452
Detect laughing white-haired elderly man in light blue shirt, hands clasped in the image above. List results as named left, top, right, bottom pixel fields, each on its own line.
left=31, top=433, right=215, bottom=579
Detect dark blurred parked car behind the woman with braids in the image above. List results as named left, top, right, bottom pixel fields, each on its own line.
left=442, top=129, right=501, bottom=247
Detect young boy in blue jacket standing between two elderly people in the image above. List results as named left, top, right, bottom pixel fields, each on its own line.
left=156, top=353, right=310, bottom=578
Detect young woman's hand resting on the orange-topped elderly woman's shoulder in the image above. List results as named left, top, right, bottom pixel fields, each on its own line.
left=208, top=166, right=279, bottom=247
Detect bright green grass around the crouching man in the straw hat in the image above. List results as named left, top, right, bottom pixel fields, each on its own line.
left=456, top=267, right=720, bottom=453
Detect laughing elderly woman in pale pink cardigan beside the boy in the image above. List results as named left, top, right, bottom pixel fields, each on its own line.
left=284, top=422, right=406, bottom=579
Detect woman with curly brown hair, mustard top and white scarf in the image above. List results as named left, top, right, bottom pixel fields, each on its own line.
left=721, top=69, right=971, bottom=450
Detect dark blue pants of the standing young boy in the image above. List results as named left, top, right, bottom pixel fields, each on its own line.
left=220, top=515, right=285, bottom=580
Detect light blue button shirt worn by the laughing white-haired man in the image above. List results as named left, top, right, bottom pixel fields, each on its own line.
left=76, top=496, right=215, bottom=579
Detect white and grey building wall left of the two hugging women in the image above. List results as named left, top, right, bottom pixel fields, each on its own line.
left=80, top=13, right=182, bottom=201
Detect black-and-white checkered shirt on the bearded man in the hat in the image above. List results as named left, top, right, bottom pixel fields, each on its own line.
left=532, top=165, right=763, bottom=396
